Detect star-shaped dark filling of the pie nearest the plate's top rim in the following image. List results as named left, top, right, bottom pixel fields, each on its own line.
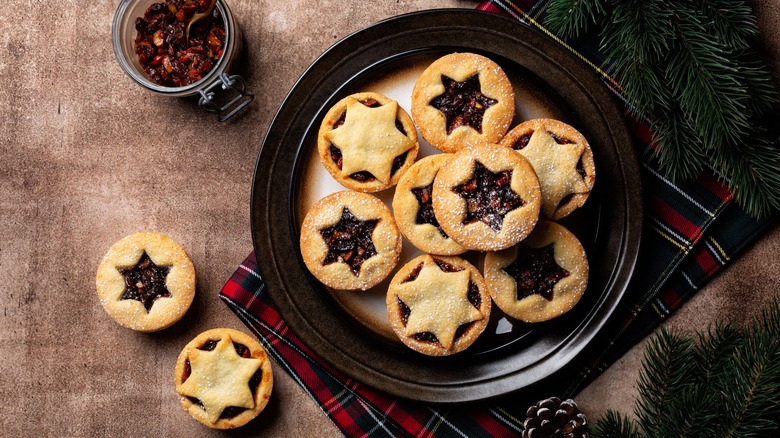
left=431, top=73, right=498, bottom=135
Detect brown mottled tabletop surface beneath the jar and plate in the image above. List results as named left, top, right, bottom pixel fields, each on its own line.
left=0, top=0, right=780, bottom=438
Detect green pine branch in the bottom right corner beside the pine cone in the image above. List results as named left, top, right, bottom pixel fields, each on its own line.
left=592, top=296, right=780, bottom=438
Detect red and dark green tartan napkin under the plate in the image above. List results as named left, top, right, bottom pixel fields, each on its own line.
left=220, top=0, right=774, bottom=437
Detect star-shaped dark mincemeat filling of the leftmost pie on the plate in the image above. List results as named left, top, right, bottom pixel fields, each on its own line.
left=320, top=207, right=379, bottom=277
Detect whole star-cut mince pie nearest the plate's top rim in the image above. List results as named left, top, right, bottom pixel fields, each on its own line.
left=412, top=53, right=515, bottom=152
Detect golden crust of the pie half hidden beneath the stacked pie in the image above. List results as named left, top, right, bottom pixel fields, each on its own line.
left=393, top=154, right=467, bottom=255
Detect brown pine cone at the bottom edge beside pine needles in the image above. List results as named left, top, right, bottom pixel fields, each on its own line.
left=523, top=397, right=588, bottom=438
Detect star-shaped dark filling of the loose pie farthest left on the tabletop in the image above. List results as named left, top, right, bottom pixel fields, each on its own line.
left=117, top=251, right=171, bottom=313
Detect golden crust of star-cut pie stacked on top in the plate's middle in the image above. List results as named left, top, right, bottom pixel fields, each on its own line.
left=433, top=144, right=541, bottom=251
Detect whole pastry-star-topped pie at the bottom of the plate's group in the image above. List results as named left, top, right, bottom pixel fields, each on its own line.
left=386, top=254, right=492, bottom=356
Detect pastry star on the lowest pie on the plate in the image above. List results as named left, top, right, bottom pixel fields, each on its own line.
left=398, top=259, right=485, bottom=349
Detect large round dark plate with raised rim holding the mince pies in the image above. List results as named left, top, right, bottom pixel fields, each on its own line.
left=251, top=10, right=642, bottom=402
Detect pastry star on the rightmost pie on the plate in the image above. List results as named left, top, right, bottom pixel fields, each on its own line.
left=519, top=129, right=589, bottom=216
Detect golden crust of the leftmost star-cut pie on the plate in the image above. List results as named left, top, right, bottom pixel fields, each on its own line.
left=300, top=190, right=402, bottom=290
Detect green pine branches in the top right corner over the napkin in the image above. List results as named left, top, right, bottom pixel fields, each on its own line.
left=545, top=0, right=780, bottom=217
